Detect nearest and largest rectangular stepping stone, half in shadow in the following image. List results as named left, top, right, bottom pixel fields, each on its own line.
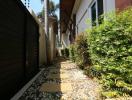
left=40, top=83, right=72, bottom=92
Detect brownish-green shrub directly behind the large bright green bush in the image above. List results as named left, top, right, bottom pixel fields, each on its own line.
left=75, top=33, right=91, bottom=69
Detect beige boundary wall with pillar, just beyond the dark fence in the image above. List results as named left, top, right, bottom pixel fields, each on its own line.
left=31, top=11, right=58, bottom=66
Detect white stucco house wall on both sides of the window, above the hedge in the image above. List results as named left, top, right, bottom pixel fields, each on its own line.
left=73, top=0, right=115, bottom=33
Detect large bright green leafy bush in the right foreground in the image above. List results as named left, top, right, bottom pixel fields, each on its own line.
left=88, top=8, right=132, bottom=97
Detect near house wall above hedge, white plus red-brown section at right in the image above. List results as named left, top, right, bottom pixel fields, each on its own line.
left=72, top=0, right=132, bottom=34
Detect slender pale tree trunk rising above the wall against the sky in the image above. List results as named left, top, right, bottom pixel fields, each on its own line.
left=44, top=0, right=49, bottom=38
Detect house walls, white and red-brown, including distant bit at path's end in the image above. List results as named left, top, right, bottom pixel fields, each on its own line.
left=62, top=0, right=132, bottom=46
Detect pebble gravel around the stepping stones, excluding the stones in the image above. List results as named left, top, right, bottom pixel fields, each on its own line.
left=19, top=61, right=101, bottom=100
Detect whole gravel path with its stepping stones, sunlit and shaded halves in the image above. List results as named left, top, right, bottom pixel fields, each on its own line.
left=19, top=58, right=100, bottom=100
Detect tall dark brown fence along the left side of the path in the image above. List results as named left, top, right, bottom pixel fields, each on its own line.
left=0, top=0, right=39, bottom=100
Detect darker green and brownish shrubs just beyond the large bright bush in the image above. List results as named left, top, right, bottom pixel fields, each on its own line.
left=70, top=33, right=91, bottom=69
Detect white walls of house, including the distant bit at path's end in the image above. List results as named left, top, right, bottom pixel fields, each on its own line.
left=62, top=0, right=115, bottom=47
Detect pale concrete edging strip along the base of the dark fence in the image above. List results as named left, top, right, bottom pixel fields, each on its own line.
left=10, top=68, right=44, bottom=100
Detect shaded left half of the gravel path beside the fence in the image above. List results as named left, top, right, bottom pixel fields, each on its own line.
left=19, top=57, right=66, bottom=100
